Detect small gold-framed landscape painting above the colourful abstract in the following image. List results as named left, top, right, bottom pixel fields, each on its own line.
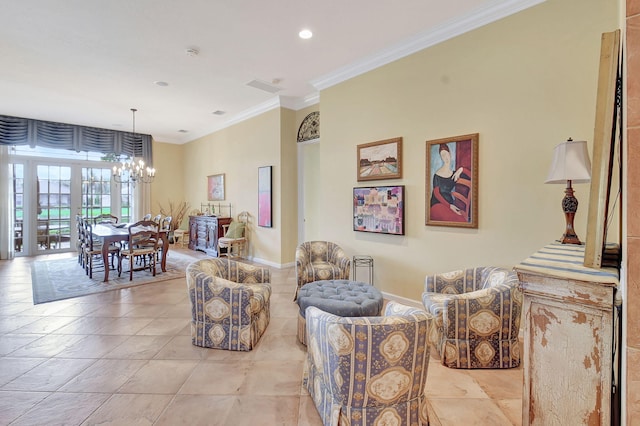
left=357, top=137, right=402, bottom=182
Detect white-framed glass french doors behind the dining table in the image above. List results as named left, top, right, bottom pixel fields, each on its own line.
left=11, top=158, right=133, bottom=256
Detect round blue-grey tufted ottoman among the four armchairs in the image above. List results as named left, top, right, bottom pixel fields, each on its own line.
left=297, top=280, right=382, bottom=345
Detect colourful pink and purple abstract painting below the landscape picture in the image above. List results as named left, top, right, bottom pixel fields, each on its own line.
left=353, top=185, right=405, bottom=235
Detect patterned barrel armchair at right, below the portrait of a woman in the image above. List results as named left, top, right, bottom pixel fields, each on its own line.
left=422, top=267, right=522, bottom=368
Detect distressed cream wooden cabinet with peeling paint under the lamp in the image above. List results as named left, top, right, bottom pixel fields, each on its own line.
left=515, top=243, right=619, bottom=426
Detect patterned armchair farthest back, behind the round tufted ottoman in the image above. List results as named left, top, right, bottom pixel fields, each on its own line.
left=293, top=241, right=351, bottom=300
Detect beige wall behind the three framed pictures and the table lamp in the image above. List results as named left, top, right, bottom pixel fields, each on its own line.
left=307, top=0, right=618, bottom=300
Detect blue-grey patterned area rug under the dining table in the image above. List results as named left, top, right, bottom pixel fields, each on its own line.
left=31, top=250, right=199, bottom=305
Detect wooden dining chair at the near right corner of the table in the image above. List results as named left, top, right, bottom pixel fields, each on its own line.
left=118, top=220, right=160, bottom=281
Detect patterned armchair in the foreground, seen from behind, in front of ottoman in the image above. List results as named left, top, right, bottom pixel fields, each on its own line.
left=304, top=302, right=431, bottom=426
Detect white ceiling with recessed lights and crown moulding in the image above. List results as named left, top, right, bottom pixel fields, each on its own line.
left=0, top=0, right=543, bottom=143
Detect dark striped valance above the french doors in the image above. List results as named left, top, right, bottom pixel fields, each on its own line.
left=0, top=115, right=153, bottom=166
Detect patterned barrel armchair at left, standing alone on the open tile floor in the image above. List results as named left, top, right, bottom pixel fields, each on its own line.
left=187, top=259, right=271, bottom=351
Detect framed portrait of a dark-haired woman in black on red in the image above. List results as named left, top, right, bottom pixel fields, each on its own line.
left=425, top=133, right=479, bottom=228
